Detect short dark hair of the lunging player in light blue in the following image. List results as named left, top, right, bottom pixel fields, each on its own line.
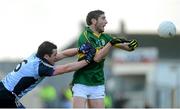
left=36, top=41, right=57, bottom=59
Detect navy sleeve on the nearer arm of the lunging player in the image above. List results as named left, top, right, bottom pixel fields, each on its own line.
left=38, top=63, right=54, bottom=77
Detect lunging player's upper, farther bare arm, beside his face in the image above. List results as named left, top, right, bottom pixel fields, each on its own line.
left=56, top=48, right=78, bottom=62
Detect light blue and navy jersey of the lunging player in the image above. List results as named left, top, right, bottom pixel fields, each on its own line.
left=2, top=54, right=54, bottom=98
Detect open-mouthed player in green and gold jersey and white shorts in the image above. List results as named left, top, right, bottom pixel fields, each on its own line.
left=72, top=10, right=137, bottom=108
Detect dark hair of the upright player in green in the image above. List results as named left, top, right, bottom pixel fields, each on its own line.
left=86, top=10, right=104, bottom=25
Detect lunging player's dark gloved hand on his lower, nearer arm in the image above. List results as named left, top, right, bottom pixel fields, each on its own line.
left=84, top=48, right=96, bottom=63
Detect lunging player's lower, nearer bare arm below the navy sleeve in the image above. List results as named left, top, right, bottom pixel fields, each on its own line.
left=53, top=60, right=88, bottom=76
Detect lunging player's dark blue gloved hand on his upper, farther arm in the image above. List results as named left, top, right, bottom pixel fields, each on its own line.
left=78, top=42, right=93, bottom=53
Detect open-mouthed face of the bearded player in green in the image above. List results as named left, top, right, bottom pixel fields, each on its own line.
left=95, top=14, right=108, bottom=33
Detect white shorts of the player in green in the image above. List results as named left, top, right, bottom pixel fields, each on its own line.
left=72, top=84, right=105, bottom=99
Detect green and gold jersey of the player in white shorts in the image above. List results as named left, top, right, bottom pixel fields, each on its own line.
left=72, top=27, right=112, bottom=86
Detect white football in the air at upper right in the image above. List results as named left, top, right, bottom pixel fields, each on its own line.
left=158, top=21, right=176, bottom=38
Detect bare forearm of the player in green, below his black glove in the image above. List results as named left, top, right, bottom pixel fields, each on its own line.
left=94, top=42, right=112, bottom=62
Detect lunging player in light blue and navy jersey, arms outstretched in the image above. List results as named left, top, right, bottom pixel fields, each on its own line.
left=0, top=41, right=96, bottom=108
